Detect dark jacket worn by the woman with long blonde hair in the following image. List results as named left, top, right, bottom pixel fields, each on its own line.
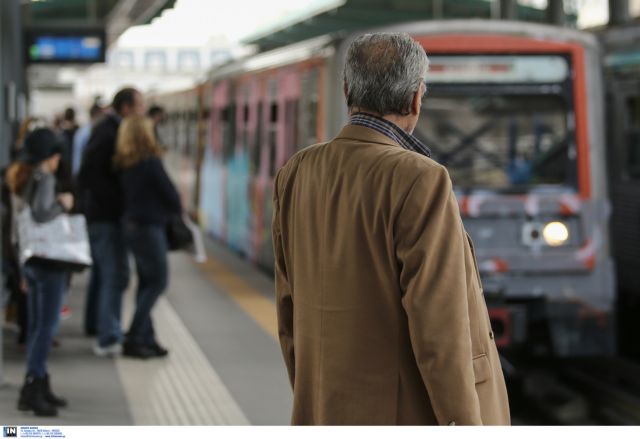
left=120, top=157, right=182, bottom=226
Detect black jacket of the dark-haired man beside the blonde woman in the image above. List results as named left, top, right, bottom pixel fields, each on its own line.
left=78, top=114, right=124, bottom=223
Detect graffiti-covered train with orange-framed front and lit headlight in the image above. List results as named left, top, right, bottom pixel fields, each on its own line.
left=150, top=20, right=640, bottom=357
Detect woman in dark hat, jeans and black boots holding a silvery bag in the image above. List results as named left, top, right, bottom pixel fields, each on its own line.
left=7, top=128, right=73, bottom=416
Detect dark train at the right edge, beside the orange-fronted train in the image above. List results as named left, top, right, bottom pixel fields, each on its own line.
left=596, top=21, right=640, bottom=360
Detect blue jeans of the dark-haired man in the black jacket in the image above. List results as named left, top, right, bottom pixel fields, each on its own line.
left=89, top=222, right=129, bottom=347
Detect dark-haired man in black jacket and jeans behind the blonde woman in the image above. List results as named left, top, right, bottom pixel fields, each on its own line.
left=77, top=88, right=145, bottom=356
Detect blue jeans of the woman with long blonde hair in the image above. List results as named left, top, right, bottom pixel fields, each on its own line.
left=125, top=222, right=169, bottom=346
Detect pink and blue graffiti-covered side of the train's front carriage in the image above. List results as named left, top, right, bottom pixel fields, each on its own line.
left=200, top=59, right=324, bottom=268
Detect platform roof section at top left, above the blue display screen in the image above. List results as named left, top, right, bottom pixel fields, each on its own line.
left=22, top=0, right=176, bottom=44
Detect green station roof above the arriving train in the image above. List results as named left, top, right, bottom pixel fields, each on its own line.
left=243, top=0, right=576, bottom=51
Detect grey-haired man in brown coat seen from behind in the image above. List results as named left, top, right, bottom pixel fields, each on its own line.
left=273, top=34, right=510, bottom=425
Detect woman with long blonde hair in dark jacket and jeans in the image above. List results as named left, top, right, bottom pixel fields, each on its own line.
left=114, top=116, right=182, bottom=358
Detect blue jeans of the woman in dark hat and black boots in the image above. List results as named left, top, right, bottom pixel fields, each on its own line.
left=24, top=263, right=67, bottom=378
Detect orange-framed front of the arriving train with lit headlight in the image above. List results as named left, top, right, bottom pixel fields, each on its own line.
left=390, top=22, right=615, bottom=356
